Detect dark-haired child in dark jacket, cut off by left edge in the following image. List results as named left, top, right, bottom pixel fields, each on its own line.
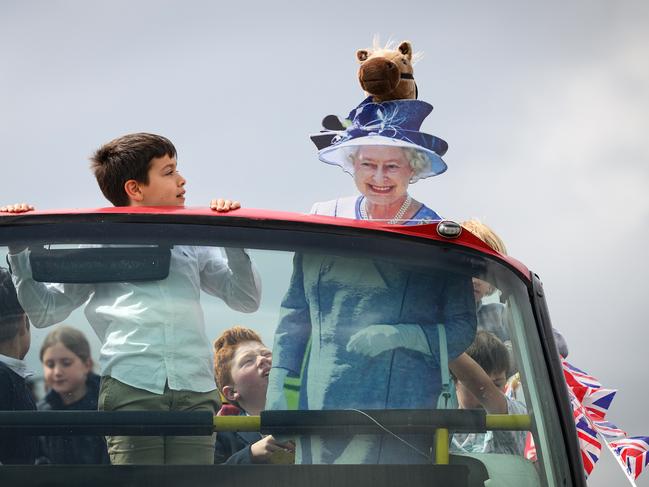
left=0, top=267, right=38, bottom=465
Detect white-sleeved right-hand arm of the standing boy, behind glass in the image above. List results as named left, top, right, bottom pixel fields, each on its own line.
left=201, top=248, right=261, bottom=313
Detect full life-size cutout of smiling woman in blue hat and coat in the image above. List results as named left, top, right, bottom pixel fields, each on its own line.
left=266, top=100, right=476, bottom=464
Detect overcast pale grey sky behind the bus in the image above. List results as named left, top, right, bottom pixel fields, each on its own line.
left=0, top=0, right=649, bottom=486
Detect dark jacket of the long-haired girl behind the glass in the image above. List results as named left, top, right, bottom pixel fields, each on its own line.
left=38, top=373, right=110, bottom=464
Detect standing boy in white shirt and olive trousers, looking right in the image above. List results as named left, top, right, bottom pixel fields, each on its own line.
left=8, top=133, right=261, bottom=464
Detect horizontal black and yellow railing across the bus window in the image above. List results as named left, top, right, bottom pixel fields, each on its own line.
left=0, top=409, right=531, bottom=436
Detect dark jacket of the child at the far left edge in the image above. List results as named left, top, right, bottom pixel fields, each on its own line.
left=0, top=362, right=38, bottom=465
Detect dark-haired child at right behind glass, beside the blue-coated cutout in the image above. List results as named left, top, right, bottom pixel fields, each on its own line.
left=449, top=330, right=527, bottom=455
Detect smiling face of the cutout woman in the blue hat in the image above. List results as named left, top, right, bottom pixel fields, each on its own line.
left=352, top=145, right=414, bottom=206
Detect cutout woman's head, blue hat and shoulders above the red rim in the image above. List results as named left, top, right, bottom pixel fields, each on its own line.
left=311, top=97, right=448, bottom=225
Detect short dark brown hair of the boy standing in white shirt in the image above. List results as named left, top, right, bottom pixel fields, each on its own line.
left=90, top=133, right=176, bottom=206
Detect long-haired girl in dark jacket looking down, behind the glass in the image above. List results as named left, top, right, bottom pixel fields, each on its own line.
left=38, top=326, right=110, bottom=464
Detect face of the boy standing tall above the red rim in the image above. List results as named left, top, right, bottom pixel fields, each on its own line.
left=131, top=156, right=186, bottom=206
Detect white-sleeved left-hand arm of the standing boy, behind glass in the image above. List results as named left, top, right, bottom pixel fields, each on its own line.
left=7, top=249, right=92, bottom=328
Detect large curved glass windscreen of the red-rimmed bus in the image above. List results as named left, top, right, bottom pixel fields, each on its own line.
left=0, top=224, right=569, bottom=485
